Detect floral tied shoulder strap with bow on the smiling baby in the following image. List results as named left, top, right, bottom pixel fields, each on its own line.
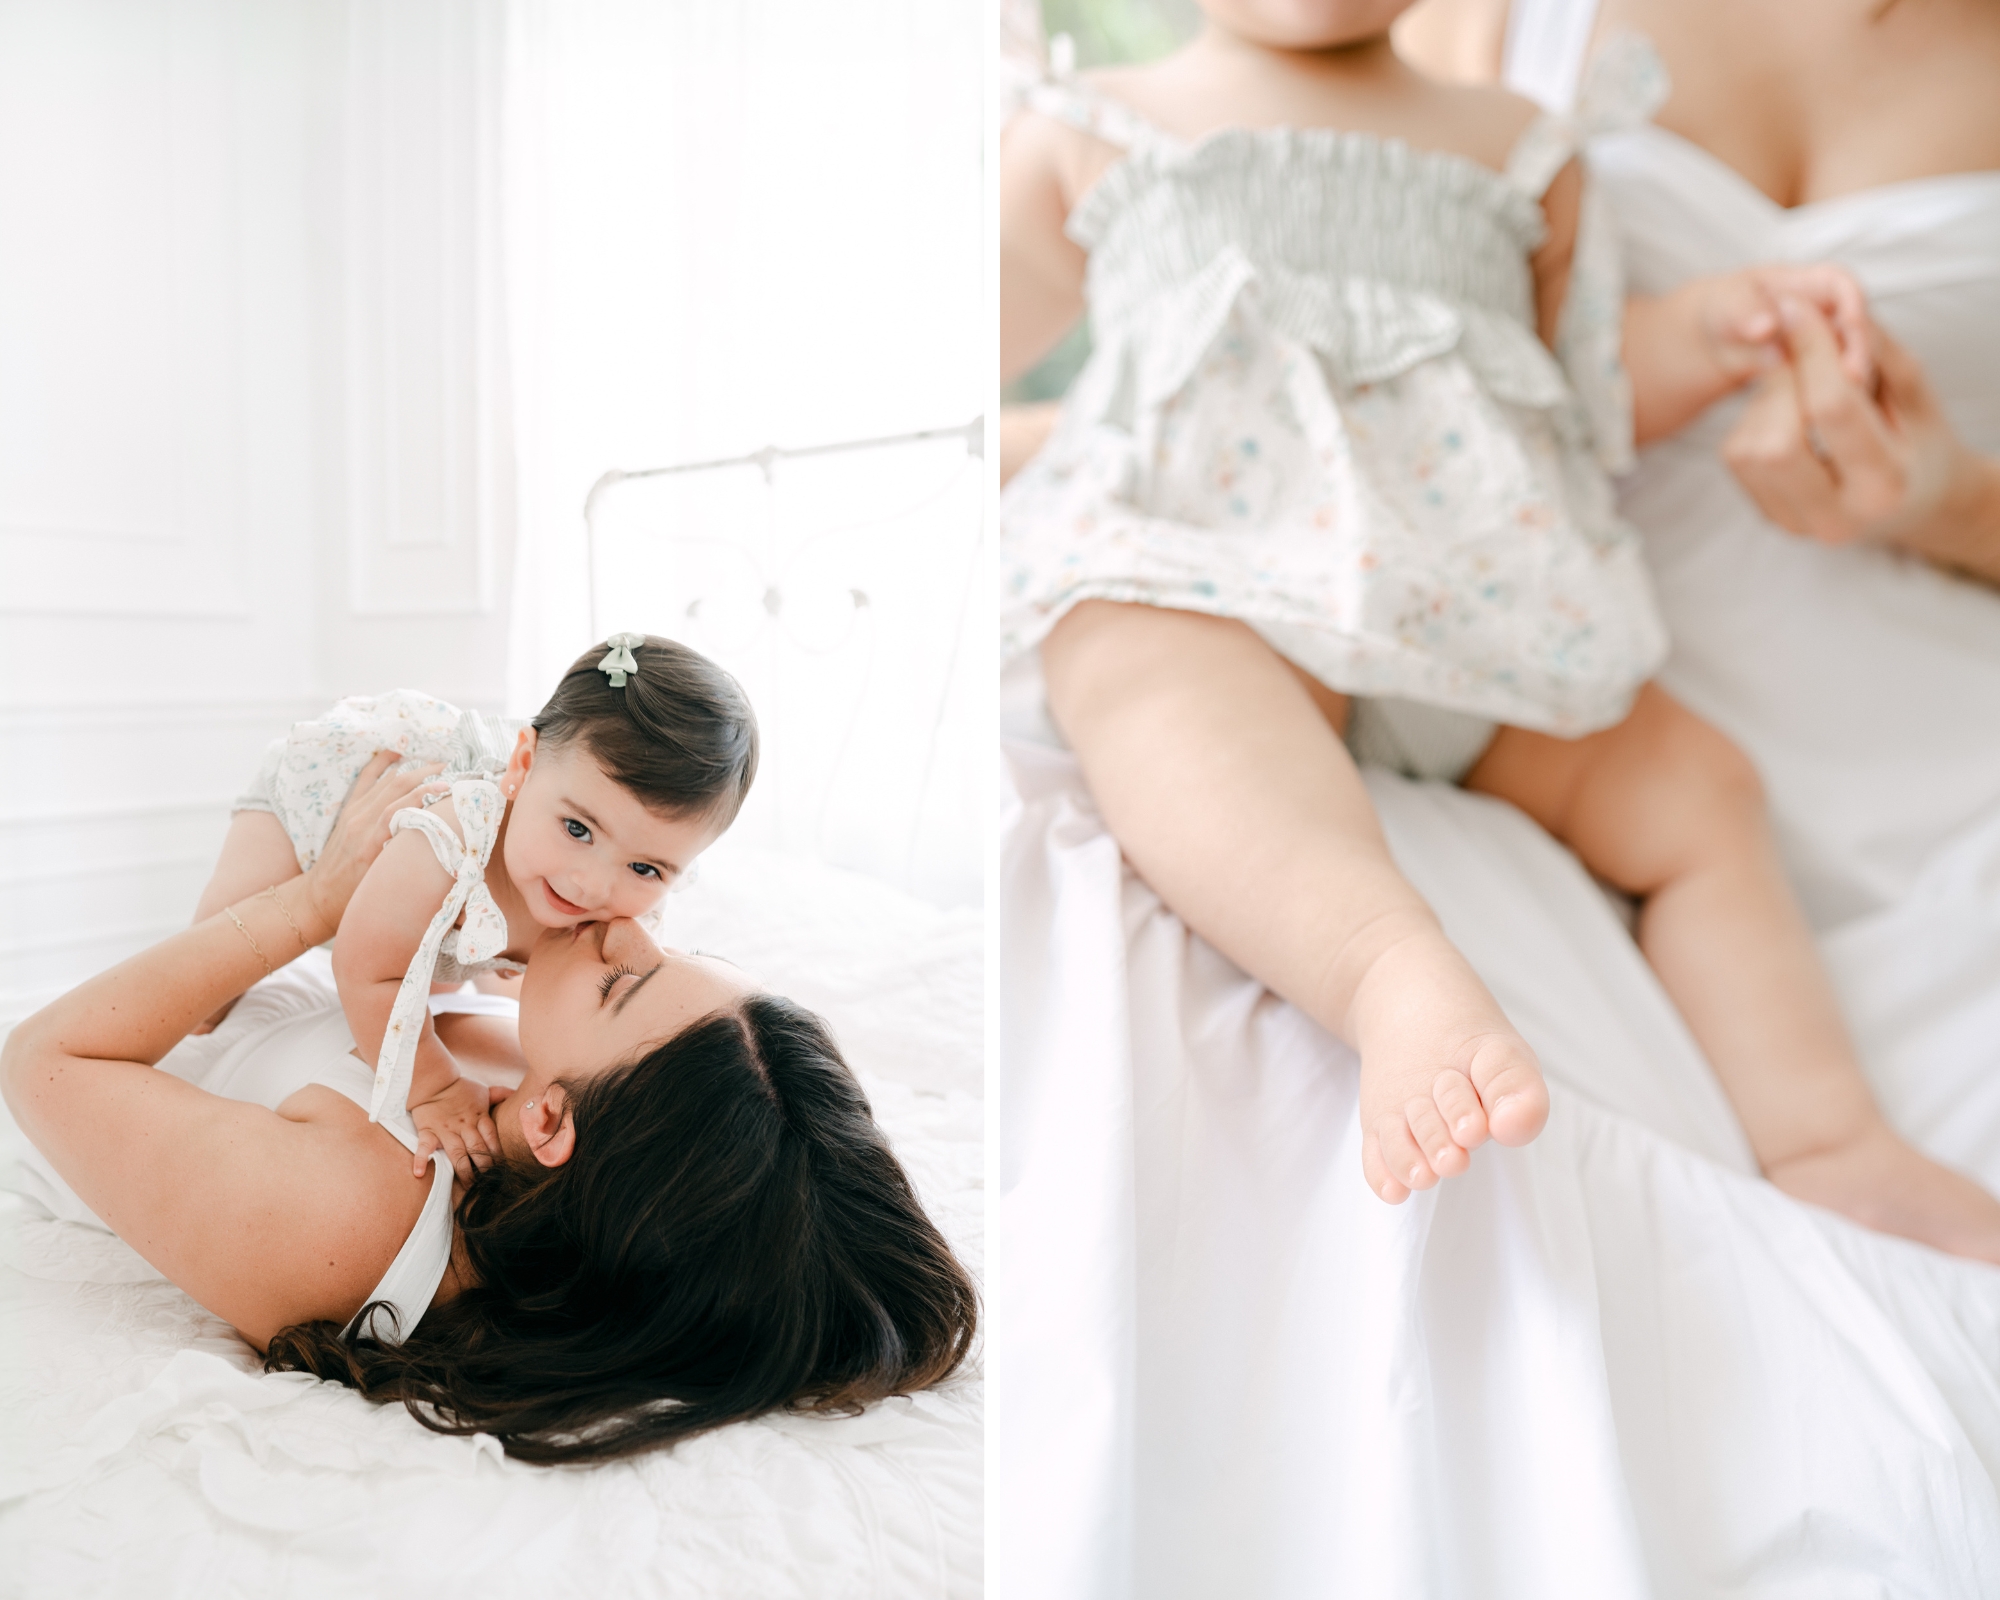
left=368, top=778, right=506, bottom=1122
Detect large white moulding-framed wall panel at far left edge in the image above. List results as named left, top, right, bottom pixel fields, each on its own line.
left=0, top=0, right=248, bottom=616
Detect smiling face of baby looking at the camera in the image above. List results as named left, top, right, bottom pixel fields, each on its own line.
left=502, top=728, right=722, bottom=928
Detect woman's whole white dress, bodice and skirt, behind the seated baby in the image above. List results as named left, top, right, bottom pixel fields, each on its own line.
left=988, top=0, right=2000, bottom=1600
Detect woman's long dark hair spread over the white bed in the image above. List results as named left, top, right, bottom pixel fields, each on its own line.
left=264, top=994, right=976, bottom=1462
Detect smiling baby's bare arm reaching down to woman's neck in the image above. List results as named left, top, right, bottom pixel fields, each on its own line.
left=334, top=820, right=500, bottom=1182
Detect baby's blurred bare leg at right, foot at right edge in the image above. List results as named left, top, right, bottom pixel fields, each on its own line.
left=1466, top=684, right=2000, bottom=1260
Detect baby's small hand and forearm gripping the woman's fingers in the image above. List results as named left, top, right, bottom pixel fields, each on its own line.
left=1624, top=264, right=1874, bottom=444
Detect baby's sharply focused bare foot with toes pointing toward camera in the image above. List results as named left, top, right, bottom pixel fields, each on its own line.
left=1354, top=932, right=1548, bottom=1206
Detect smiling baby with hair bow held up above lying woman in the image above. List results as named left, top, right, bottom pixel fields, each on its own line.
left=194, top=634, right=758, bottom=1180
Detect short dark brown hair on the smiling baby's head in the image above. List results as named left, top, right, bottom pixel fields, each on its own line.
left=530, top=634, right=756, bottom=828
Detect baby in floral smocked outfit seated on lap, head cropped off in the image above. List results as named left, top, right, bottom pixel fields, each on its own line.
left=1000, top=0, right=2000, bottom=1260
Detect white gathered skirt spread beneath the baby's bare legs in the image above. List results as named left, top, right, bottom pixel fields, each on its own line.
left=992, top=664, right=2000, bottom=1600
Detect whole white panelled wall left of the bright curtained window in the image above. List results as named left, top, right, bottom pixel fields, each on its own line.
left=0, top=0, right=514, bottom=1028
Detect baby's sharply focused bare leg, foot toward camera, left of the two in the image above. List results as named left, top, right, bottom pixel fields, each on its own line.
left=1042, top=602, right=1548, bottom=1202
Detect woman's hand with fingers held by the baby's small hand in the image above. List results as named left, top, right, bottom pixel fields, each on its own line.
left=1722, top=296, right=2000, bottom=578
